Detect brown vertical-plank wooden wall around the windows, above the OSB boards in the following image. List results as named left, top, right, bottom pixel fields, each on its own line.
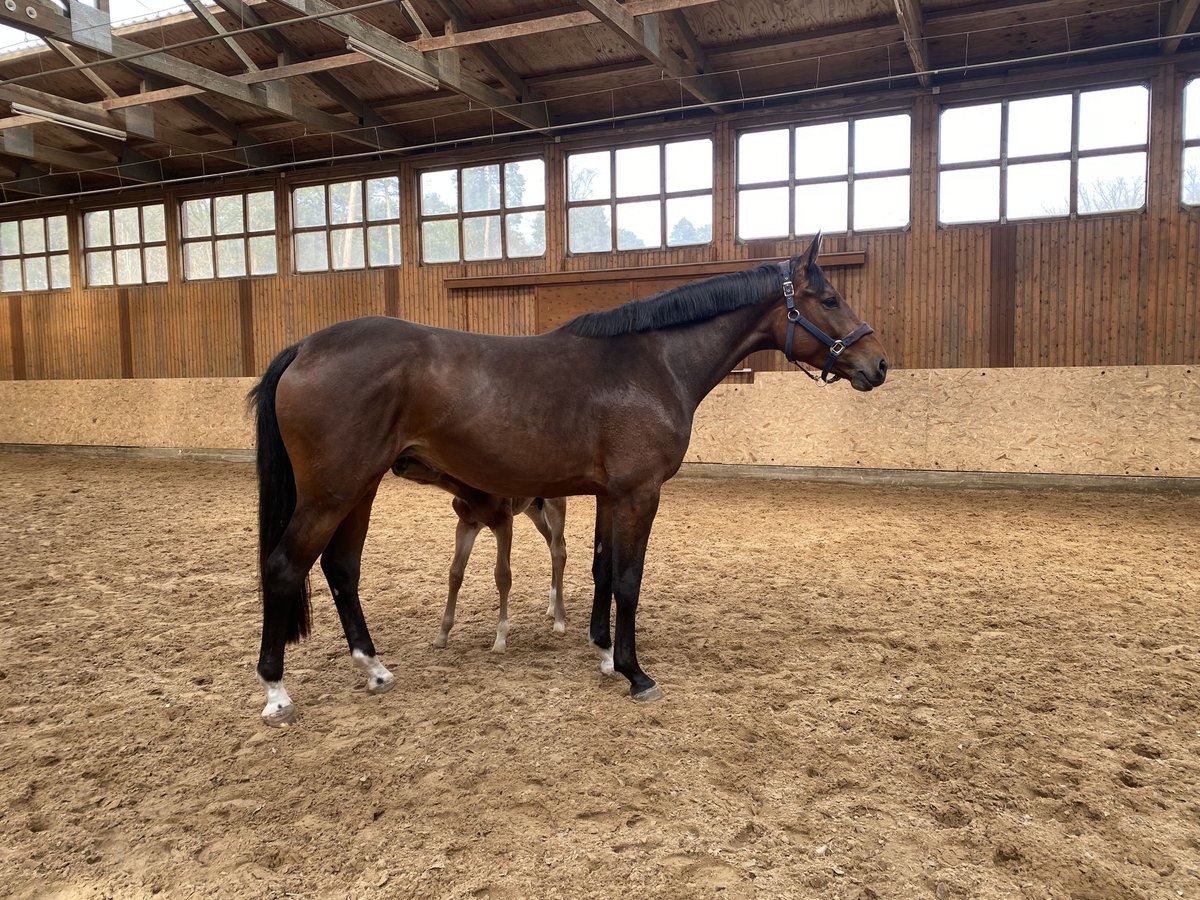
left=0, top=59, right=1200, bottom=379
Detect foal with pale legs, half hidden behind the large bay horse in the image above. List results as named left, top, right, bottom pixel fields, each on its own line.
left=391, top=456, right=566, bottom=653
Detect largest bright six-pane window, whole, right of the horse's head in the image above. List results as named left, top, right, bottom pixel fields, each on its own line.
left=937, top=85, right=1150, bottom=224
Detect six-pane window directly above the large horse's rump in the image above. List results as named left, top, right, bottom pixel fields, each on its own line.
left=292, top=175, right=400, bottom=272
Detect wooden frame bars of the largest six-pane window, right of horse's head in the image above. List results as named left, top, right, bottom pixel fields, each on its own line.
left=936, top=82, right=1152, bottom=228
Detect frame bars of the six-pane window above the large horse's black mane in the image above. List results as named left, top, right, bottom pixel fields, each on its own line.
left=563, top=133, right=718, bottom=257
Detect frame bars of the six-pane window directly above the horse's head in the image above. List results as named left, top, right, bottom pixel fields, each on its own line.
left=733, top=107, right=913, bottom=245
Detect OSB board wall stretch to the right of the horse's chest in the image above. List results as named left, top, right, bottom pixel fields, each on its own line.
left=686, top=366, right=1200, bottom=476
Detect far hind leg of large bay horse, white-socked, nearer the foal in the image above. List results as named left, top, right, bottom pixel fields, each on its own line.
left=320, top=485, right=396, bottom=694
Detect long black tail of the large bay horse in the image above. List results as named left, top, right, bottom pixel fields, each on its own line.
left=246, top=344, right=312, bottom=642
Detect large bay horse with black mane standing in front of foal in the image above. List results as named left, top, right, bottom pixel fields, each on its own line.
left=248, top=235, right=888, bottom=725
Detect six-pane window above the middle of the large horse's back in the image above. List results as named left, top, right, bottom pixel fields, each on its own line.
left=421, top=160, right=546, bottom=263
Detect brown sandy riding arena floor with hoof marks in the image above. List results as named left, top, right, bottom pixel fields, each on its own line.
left=0, top=454, right=1200, bottom=900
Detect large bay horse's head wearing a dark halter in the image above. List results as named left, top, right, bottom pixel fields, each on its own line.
left=772, top=234, right=888, bottom=391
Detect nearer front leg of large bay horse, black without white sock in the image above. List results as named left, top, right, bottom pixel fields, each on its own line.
left=612, top=485, right=662, bottom=701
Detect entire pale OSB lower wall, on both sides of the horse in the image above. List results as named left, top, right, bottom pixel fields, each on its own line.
left=0, top=366, right=1200, bottom=478
